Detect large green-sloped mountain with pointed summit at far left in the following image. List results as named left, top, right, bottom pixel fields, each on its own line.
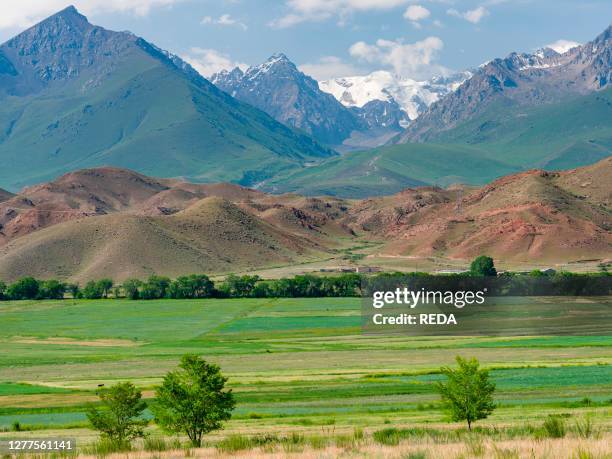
left=0, top=8, right=334, bottom=190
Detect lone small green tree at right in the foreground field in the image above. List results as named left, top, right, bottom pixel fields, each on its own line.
left=436, top=356, right=495, bottom=430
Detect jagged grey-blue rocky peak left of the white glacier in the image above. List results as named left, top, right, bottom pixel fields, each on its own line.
left=211, top=53, right=362, bottom=145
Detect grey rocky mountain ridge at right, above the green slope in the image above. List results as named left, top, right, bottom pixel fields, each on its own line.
left=398, top=26, right=612, bottom=143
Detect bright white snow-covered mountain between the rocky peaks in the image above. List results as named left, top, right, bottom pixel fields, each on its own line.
left=319, top=70, right=472, bottom=127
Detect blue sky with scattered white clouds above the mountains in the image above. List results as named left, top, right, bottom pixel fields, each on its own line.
left=0, top=0, right=612, bottom=79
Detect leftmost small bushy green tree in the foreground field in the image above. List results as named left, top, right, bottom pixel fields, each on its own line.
left=87, top=382, right=147, bottom=444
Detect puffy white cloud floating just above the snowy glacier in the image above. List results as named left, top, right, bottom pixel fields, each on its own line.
left=349, top=37, right=448, bottom=79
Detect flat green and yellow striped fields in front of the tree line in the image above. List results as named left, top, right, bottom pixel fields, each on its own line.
left=0, top=298, right=612, bottom=458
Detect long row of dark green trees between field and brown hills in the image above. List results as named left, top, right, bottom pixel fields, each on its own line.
left=0, top=255, right=612, bottom=300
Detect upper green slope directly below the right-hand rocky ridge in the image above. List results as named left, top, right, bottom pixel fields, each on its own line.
left=435, top=88, right=612, bottom=169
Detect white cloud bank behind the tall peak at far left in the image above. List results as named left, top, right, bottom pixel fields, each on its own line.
left=0, top=0, right=184, bottom=29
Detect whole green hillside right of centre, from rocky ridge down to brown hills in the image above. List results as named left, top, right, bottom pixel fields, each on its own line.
left=263, top=89, right=612, bottom=197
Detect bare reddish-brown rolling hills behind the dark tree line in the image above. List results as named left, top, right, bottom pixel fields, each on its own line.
left=0, top=163, right=612, bottom=281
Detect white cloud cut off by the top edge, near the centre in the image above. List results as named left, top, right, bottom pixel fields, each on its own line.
left=269, top=0, right=410, bottom=29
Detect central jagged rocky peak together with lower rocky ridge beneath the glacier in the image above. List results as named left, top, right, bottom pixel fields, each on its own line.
left=211, top=53, right=416, bottom=150
